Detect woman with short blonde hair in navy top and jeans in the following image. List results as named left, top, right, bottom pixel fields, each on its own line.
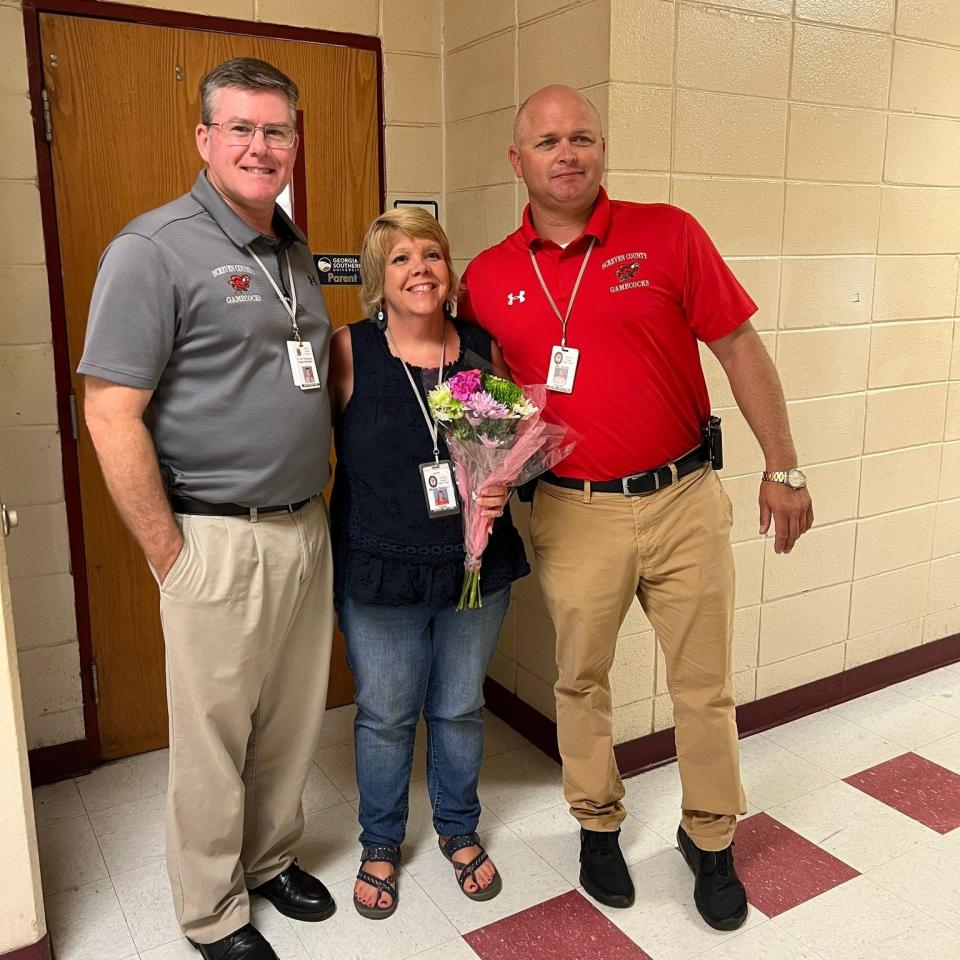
left=329, top=208, right=529, bottom=919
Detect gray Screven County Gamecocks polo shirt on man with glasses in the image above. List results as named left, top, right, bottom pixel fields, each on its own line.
left=77, top=173, right=331, bottom=507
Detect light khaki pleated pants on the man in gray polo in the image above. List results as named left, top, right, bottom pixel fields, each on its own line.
left=160, top=499, right=333, bottom=943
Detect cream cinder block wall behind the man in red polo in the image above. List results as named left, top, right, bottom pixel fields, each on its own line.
left=444, top=0, right=960, bottom=742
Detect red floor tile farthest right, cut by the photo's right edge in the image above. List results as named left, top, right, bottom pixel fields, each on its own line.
left=846, top=753, right=960, bottom=833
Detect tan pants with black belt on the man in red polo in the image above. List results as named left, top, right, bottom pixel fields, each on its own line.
left=530, top=467, right=746, bottom=850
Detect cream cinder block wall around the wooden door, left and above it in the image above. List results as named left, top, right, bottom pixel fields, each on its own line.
left=0, top=0, right=443, bottom=749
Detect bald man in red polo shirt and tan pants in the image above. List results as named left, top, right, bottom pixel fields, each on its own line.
left=462, top=86, right=813, bottom=930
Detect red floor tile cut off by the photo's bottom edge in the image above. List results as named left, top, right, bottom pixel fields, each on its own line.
left=463, top=890, right=650, bottom=960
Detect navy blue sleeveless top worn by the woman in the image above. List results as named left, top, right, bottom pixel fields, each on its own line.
left=330, top=320, right=530, bottom=606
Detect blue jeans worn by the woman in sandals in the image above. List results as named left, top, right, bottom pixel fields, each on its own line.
left=338, top=588, right=510, bottom=847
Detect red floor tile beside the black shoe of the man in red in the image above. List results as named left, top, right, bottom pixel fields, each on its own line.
left=734, top=813, right=859, bottom=917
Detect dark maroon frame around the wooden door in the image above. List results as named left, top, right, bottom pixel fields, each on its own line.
left=23, top=0, right=386, bottom=786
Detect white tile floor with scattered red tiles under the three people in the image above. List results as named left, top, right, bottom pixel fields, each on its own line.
left=35, top=665, right=960, bottom=960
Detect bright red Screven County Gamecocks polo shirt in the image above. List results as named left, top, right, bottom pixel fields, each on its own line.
left=460, top=188, right=757, bottom=481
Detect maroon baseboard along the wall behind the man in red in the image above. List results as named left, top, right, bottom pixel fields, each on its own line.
left=483, top=633, right=960, bottom=777
